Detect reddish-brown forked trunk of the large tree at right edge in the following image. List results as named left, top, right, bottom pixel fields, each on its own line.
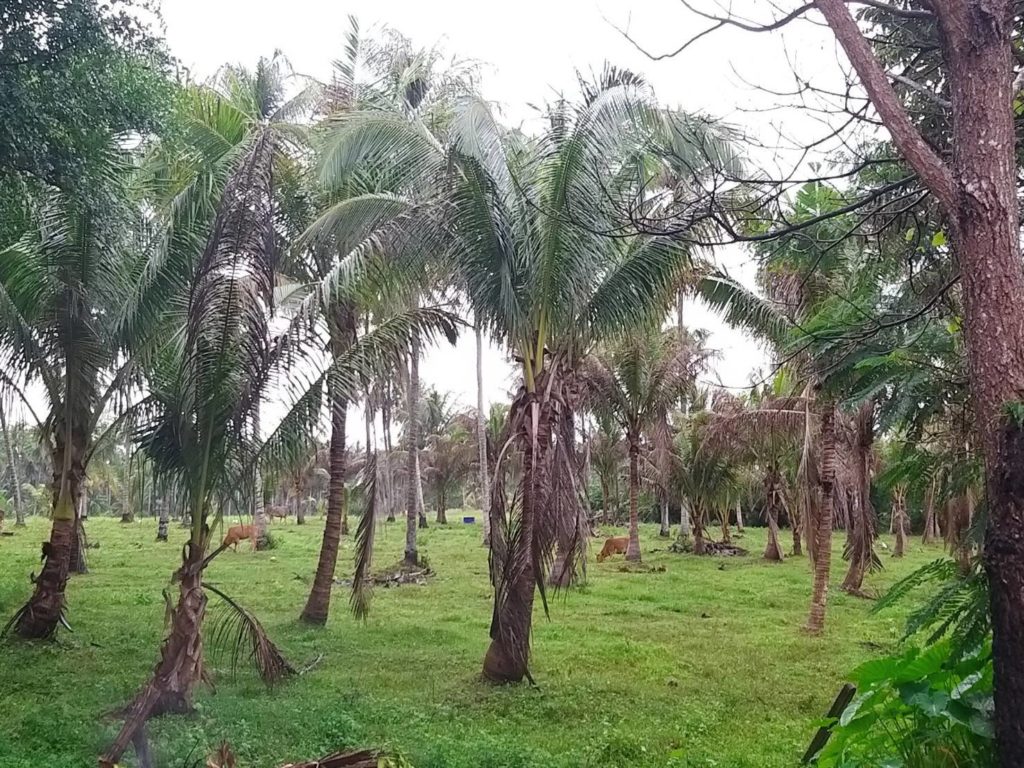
left=816, top=0, right=1024, bottom=757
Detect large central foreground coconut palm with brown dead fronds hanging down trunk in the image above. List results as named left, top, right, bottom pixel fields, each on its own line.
left=323, top=63, right=733, bottom=682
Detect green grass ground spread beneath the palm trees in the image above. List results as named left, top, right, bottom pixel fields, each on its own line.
left=0, top=512, right=940, bottom=768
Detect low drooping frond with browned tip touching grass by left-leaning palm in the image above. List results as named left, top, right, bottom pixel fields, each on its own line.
left=203, top=583, right=295, bottom=685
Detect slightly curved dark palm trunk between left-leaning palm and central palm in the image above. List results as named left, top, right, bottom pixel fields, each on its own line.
left=299, top=396, right=348, bottom=626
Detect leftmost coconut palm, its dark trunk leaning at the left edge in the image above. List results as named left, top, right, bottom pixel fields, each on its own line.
left=0, top=177, right=154, bottom=638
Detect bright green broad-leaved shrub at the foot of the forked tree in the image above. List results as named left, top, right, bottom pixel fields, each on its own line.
left=817, top=639, right=994, bottom=768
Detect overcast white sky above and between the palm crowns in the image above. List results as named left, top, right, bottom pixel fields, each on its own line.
left=163, top=0, right=838, bottom=421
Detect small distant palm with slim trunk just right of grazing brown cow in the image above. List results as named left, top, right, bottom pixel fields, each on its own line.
left=583, top=328, right=708, bottom=561
